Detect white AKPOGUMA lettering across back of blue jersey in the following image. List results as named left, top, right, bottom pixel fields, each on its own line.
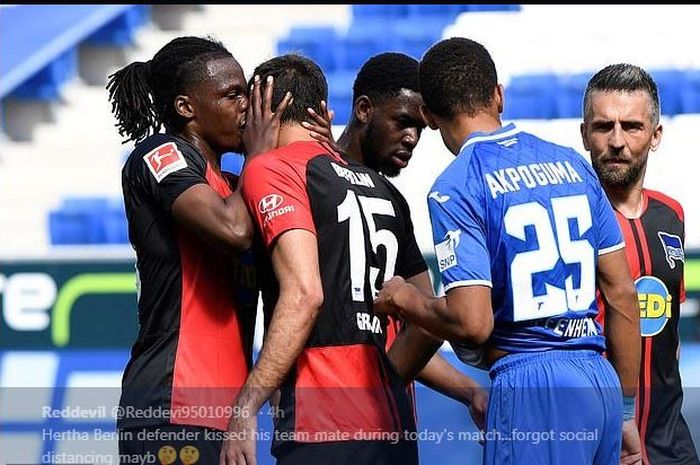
left=484, top=161, right=583, bottom=199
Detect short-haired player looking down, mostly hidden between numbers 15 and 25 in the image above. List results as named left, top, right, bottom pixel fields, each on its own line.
left=338, top=52, right=488, bottom=429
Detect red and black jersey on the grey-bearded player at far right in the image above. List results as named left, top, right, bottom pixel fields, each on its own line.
left=601, top=189, right=700, bottom=465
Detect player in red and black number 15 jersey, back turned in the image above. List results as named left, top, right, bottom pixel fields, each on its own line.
left=220, top=55, right=440, bottom=465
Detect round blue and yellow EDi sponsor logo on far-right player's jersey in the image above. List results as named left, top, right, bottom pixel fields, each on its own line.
left=634, top=276, right=673, bottom=337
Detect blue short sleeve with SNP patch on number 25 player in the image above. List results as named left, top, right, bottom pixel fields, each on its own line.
left=428, top=170, right=492, bottom=292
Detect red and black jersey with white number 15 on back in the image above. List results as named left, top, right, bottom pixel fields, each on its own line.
left=243, top=142, right=427, bottom=452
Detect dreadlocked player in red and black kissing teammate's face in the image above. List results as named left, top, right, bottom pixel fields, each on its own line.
left=108, top=37, right=290, bottom=463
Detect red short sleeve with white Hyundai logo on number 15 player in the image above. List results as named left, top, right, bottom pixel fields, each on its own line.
left=241, top=154, right=316, bottom=249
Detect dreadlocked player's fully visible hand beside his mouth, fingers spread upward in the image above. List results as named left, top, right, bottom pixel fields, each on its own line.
left=243, top=76, right=294, bottom=157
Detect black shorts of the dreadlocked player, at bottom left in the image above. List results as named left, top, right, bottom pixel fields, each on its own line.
left=119, top=425, right=222, bottom=465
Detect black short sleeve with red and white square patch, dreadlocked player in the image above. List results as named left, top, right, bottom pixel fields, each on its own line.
left=134, top=141, right=207, bottom=212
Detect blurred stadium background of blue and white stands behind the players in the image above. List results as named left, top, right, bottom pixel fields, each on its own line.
left=0, top=4, right=700, bottom=465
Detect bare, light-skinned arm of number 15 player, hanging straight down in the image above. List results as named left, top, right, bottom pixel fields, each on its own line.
left=220, top=229, right=323, bottom=464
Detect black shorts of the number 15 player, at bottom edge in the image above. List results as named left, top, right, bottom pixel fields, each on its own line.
left=276, top=441, right=418, bottom=465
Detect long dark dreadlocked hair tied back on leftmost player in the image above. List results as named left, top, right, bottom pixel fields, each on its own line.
left=107, top=37, right=233, bottom=143
